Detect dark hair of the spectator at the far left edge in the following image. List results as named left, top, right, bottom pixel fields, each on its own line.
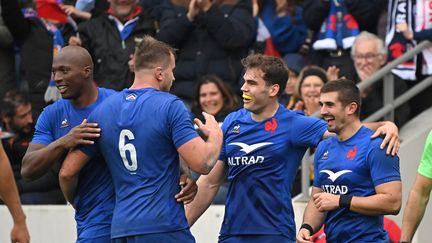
left=1, top=90, right=30, bottom=117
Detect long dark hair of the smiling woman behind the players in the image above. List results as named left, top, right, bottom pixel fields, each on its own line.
left=192, top=74, right=239, bottom=120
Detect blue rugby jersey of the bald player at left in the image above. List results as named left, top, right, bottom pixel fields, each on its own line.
left=32, top=88, right=116, bottom=242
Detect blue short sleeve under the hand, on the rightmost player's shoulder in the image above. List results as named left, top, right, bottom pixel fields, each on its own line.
left=367, top=143, right=401, bottom=186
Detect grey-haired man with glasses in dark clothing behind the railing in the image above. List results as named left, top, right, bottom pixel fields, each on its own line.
left=351, top=31, right=410, bottom=127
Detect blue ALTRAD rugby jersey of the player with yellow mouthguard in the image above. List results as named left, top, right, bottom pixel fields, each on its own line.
left=220, top=105, right=327, bottom=241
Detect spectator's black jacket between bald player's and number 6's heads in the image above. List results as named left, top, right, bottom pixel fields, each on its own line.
left=78, top=12, right=156, bottom=90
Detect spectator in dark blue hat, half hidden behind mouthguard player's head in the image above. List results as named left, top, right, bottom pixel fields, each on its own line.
left=279, top=54, right=305, bottom=110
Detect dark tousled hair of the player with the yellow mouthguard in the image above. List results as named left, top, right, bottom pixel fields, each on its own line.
left=242, top=54, right=289, bottom=97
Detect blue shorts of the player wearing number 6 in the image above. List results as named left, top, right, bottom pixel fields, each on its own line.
left=111, top=229, right=195, bottom=243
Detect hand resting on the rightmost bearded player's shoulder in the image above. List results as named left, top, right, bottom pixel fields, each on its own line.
left=371, top=121, right=400, bottom=156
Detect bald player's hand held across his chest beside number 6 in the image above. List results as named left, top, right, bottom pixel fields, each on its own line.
left=61, top=119, right=101, bottom=149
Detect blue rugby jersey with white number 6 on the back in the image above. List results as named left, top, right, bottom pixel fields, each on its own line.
left=81, top=88, right=198, bottom=239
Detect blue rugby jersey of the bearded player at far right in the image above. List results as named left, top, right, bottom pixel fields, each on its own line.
left=314, top=127, right=400, bottom=242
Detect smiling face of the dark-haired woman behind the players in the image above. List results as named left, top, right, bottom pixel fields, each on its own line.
left=199, top=82, right=224, bottom=115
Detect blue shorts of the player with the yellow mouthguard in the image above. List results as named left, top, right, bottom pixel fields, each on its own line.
left=219, top=235, right=295, bottom=243
